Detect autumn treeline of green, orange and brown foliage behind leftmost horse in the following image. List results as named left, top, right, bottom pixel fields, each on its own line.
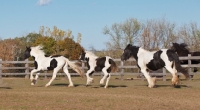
left=0, top=26, right=83, bottom=61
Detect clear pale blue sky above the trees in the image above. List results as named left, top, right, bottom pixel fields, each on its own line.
left=0, top=0, right=200, bottom=50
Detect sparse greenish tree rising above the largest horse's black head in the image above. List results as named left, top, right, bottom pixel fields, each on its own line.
left=103, top=18, right=141, bottom=49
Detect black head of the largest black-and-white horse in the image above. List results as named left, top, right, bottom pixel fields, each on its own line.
left=121, top=44, right=132, bottom=61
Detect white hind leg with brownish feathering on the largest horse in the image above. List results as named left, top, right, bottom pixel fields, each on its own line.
left=165, top=66, right=179, bottom=86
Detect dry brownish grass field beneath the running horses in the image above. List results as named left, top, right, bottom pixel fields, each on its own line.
left=0, top=76, right=200, bottom=110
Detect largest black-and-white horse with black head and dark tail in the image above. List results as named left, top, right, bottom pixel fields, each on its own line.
left=121, top=44, right=189, bottom=88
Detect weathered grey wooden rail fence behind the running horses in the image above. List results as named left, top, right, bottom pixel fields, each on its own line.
left=0, top=54, right=200, bottom=81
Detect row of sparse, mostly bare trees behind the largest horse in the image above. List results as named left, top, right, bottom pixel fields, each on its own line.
left=103, top=18, right=200, bottom=58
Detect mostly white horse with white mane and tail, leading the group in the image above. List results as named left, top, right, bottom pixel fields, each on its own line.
left=24, top=45, right=83, bottom=87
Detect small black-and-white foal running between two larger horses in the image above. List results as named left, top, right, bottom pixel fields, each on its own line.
left=79, top=50, right=118, bottom=88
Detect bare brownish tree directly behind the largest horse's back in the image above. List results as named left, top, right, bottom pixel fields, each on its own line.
left=137, top=18, right=178, bottom=50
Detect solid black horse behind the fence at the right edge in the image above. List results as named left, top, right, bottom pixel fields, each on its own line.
left=171, top=43, right=200, bottom=72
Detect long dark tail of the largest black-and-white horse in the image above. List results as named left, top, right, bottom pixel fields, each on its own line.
left=172, top=52, right=190, bottom=79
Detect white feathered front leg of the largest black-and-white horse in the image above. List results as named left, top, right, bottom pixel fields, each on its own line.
left=141, top=69, right=156, bottom=88
